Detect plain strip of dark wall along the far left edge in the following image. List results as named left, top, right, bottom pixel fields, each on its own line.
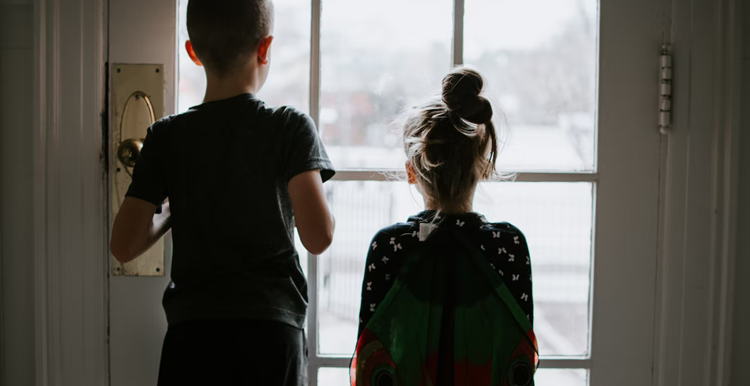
left=0, top=0, right=34, bottom=386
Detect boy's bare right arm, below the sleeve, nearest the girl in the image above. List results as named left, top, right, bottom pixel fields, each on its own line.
left=288, top=170, right=336, bottom=255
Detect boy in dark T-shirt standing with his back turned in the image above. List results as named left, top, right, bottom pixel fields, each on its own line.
left=110, top=0, right=334, bottom=386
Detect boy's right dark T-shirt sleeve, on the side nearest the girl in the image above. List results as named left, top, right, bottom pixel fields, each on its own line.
left=284, top=113, right=336, bottom=182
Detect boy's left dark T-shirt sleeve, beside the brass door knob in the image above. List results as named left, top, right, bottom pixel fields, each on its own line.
left=125, top=122, right=167, bottom=208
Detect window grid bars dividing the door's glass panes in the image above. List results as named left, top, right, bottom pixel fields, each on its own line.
left=307, top=0, right=599, bottom=380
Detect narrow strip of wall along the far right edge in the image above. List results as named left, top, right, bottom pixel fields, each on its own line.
left=730, top=1, right=750, bottom=386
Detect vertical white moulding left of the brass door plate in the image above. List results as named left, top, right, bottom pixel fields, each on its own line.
left=33, top=0, right=109, bottom=386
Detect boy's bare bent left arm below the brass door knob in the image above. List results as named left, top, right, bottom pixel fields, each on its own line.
left=109, top=197, right=171, bottom=263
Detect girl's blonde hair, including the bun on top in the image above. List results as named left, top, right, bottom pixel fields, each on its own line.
left=404, top=67, right=498, bottom=208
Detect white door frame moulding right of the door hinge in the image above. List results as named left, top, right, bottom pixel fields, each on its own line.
left=653, top=0, right=747, bottom=386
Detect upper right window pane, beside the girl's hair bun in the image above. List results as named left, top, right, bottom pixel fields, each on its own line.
left=464, top=0, right=599, bottom=171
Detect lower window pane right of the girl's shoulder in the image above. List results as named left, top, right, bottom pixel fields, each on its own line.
left=474, top=182, right=593, bottom=356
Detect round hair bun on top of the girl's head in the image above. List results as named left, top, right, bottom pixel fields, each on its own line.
left=443, top=67, right=492, bottom=125
